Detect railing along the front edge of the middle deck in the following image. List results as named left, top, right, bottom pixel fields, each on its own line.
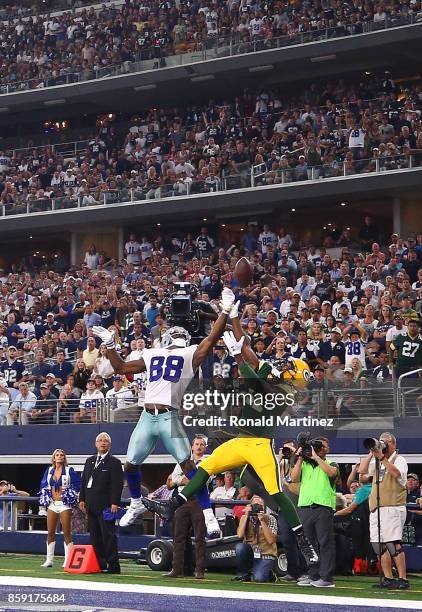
left=0, top=151, right=422, bottom=217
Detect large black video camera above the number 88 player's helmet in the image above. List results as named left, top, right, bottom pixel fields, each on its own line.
left=163, top=282, right=200, bottom=335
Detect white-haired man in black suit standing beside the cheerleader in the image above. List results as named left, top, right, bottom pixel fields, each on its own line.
left=79, top=432, right=123, bottom=574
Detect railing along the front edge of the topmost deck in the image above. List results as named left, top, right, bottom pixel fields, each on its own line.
left=0, top=17, right=422, bottom=95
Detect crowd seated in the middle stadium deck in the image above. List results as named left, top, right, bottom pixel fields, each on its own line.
left=0, top=72, right=422, bottom=214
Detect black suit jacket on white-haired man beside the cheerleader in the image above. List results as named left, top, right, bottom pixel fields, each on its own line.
left=79, top=454, right=123, bottom=514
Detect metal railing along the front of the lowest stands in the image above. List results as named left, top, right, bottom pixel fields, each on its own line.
left=4, top=378, right=422, bottom=429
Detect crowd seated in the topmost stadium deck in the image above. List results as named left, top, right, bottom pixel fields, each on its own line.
left=0, top=0, right=421, bottom=91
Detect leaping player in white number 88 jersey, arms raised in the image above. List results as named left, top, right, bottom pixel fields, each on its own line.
left=93, top=288, right=235, bottom=534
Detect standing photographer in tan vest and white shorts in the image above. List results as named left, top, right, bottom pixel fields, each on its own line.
left=359, top=432, right=410, bottom=590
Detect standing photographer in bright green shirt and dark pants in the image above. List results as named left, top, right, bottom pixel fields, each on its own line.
left=291, top=434, right=339, bottom=588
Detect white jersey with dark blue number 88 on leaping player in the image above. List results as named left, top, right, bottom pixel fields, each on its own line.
left=142, top=344, right=197, bottom=408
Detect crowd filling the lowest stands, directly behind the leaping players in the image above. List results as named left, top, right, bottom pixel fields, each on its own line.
left=0, top=217, right=422, bottom=424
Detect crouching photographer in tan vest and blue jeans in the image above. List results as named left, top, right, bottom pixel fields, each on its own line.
left=235, top=495, right=277, bottom=582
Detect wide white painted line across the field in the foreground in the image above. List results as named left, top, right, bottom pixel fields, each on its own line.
left=0, top=576, right=422, bottom=610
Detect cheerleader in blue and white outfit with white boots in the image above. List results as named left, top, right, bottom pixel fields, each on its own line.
left=38, top=448, right=81, bottom=567
